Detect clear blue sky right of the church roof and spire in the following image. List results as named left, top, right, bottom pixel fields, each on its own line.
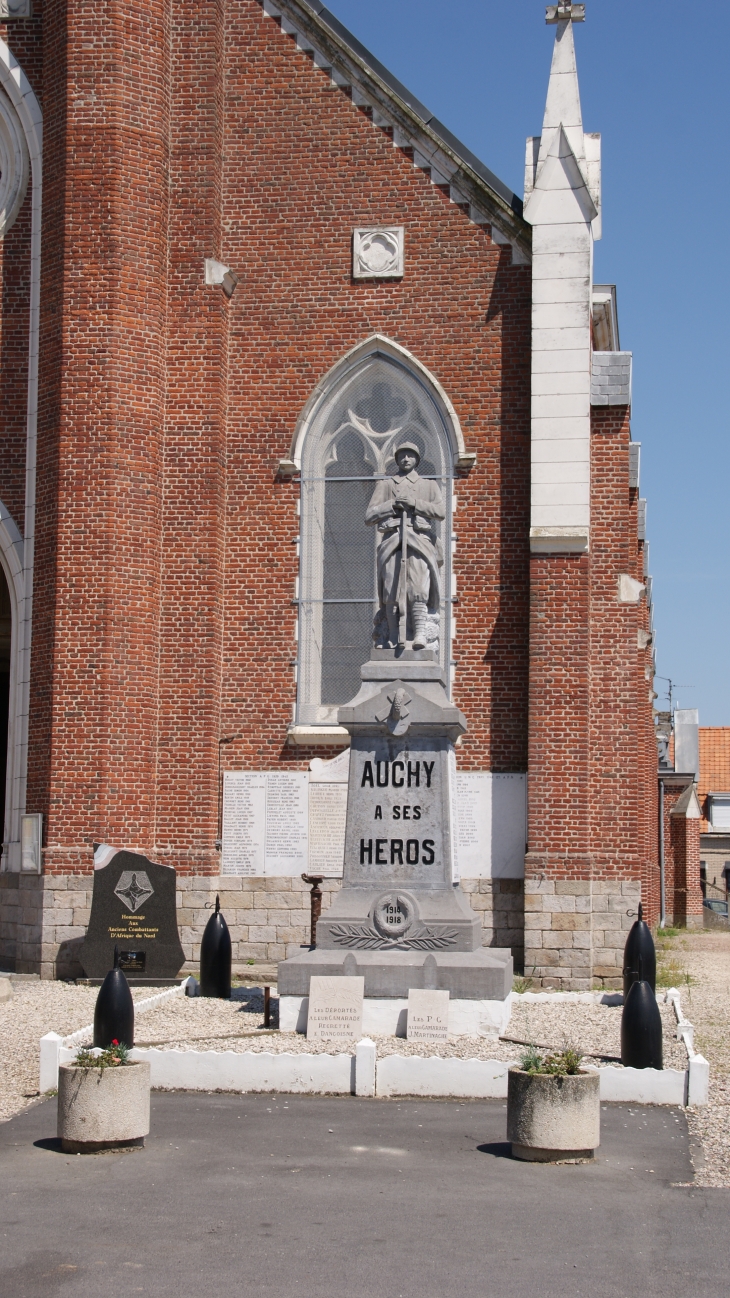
left=326, top=0, right=730, bottom=726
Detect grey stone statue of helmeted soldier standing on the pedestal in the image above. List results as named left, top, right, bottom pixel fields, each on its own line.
left=365, top=441, right=446, bottom=649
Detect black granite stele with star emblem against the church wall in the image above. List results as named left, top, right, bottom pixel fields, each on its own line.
left=79, top=844, right=184, bottom=984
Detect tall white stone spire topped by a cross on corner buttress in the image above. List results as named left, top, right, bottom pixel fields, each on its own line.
left=525, top=3, right=600, bottom=553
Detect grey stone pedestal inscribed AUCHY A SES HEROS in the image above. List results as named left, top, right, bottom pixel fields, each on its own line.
left=278, top=649, right=512, bottom=1022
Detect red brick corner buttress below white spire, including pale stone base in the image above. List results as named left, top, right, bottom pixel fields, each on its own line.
left=525, top=409, right=646, bottom=989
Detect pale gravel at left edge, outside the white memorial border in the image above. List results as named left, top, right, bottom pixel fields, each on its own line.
left=0, top=981, right=155, bottom=1121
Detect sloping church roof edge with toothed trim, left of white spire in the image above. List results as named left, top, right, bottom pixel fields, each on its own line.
left=258, top=0, right=531, bottom=263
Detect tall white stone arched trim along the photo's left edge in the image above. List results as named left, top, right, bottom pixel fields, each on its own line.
left=0, top=40, right=43, bottom=871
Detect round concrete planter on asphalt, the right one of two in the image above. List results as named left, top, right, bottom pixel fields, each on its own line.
left=507, top=1068, right=600, bottom=1163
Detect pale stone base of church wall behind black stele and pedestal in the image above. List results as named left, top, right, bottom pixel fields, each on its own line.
left=0, top=874, right=523, bottom=979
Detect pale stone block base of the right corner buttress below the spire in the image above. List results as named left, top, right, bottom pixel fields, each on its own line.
left=525, top=876, right=642, bottom=992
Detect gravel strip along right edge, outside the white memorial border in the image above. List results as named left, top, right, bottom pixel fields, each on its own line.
left=662, top=929, right=730, bottom=1189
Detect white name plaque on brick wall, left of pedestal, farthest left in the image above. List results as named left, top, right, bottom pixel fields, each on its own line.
left=221, top=771, right=303, bottom=877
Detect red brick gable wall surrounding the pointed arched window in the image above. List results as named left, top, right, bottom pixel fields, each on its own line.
left=3, top=0, right=530, bottom=971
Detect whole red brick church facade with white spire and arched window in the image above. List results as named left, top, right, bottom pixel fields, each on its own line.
left=0, top=0, right=659, bottom=988
